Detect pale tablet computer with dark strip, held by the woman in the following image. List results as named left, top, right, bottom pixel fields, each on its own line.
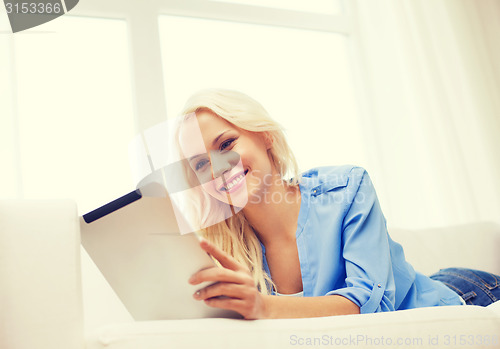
left=80, top=182, right=242, bottom=320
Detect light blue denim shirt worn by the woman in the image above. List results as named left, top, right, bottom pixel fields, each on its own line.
left=261, top=165, right=462, bottom=313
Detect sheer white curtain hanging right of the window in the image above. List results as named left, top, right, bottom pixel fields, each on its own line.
left=351, top=0, right=500, bottom=228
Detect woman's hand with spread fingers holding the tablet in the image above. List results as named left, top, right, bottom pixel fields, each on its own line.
left=189, top=239, right=266, bottom=319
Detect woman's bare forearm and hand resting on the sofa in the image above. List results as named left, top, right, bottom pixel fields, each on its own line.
left=189, top=240, right=359, bottom=319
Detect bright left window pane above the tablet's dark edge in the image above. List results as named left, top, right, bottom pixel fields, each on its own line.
left=14, top=15, right=135, bottom=213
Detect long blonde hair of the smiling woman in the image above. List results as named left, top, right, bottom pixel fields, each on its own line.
left=178, top=89, right=299, bottom=294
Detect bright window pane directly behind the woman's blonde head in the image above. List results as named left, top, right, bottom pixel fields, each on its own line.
left=159, top=15, right=365, bottom=170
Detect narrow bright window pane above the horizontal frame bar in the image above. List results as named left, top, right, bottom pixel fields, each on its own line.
left=210, top=0, right=342, bottom=15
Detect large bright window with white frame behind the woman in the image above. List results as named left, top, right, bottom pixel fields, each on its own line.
left=0, top=0, right=364, bottom=209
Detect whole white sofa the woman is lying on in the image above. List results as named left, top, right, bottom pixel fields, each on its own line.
left=0, top=201, right=500, bottom=349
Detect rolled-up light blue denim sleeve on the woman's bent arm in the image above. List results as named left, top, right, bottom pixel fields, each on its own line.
left=326, top=167, right=395, bottom=313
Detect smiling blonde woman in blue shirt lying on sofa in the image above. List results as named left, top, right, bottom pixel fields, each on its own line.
left=174, top=89, right=500, bottom=319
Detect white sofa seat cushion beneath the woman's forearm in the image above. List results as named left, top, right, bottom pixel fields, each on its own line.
left=87, top=306, right=500, bottom=349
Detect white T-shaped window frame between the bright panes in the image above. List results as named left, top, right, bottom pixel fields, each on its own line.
left=70, top=0, right=352, bottom=132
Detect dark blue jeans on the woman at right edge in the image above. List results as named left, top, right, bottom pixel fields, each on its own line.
left=430, top=268, right=500, bottom=307
